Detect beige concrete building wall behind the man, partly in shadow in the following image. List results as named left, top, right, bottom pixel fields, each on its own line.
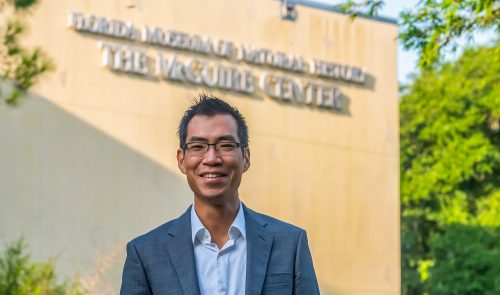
left=0, top=0, right=400, bottom=294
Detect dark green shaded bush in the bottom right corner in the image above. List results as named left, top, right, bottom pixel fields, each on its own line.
left=425, top=224, right=500, bottom=295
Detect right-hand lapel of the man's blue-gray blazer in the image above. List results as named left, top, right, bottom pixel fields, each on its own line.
left=243, top=206, right=273, bottom=295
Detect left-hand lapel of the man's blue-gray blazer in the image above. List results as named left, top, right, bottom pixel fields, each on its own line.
left=167, top=207, right=200, bottom=295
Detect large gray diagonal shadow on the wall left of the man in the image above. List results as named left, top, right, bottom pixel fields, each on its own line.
left=0, top=94, right=192, bottom=292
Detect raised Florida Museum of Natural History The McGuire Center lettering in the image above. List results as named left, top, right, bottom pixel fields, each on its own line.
left=68, top=12, right=366, bottom=111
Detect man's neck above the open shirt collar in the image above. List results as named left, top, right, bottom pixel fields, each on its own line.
left=194, top=197, right=240, bottom=249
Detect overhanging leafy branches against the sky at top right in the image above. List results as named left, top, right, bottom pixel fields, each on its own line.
left=339, top=0, right=500, bottom=68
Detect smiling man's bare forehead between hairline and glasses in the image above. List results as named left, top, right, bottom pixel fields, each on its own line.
left=186, top=114, right=238, bottom=141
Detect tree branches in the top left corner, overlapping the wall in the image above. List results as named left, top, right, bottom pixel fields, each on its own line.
left=0, top=0, right=54, bottom=105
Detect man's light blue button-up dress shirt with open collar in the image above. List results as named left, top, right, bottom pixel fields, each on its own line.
left=191, top=202, right=247, bottom=295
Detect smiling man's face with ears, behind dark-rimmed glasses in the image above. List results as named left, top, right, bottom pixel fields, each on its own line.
left=177, top=114, right=250, bottom=204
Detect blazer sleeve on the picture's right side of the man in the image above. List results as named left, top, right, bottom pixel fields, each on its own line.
left=293, top=230, right=319, bottom=295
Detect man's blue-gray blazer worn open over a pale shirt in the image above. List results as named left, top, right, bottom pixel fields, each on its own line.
left=120, top=206, right=319, bottom=295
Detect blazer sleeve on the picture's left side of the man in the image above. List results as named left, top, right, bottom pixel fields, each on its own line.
left=120, top=242, right=152, bottom=295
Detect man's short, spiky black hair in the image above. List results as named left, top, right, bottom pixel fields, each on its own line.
left=177, top=93, right=248, bottom=149
